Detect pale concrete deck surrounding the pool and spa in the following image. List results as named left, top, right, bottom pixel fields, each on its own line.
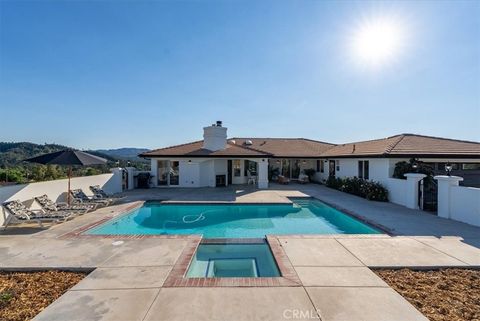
left=0, top=184, right=480, bottom=321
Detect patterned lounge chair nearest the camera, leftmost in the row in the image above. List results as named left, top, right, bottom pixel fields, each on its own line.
left=2, top=200, right=73, bottom=229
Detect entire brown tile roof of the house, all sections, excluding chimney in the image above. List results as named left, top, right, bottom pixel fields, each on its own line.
left=140, top=134, right=480, bottom=158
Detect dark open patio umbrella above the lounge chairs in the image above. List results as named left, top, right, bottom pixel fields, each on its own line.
left=24, top=149, right=107, bottom=204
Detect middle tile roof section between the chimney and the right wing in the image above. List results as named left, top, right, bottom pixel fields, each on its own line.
left=230, top=137, right=335, bottom=158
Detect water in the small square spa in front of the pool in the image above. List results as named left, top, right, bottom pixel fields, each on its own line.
left=187, top=243, right=280, bottom=278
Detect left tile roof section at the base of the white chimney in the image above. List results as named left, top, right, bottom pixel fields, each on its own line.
left=139, top=140, right=271, bottom=158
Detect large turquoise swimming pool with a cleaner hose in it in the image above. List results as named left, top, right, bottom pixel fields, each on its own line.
left=85, top=198, right=381, bottom=238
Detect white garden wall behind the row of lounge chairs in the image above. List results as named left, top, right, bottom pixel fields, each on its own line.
left=0, top=171, right=122, bottom=225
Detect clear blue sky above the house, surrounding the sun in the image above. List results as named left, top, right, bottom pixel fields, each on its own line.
left=0, top=1, right=480, bottom=148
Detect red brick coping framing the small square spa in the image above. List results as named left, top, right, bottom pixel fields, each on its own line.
left=163, top=236, right=302, bottom=287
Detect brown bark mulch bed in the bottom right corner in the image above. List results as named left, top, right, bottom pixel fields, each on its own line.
left=375, top=269, right=480, bottom=321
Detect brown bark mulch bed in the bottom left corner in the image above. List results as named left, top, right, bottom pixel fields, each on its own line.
left=0, top=271, right=85, bottom=321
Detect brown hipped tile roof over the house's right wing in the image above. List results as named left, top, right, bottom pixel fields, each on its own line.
left=322, top=134, right=480, bottom=158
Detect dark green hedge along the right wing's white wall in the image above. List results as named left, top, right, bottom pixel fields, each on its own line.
left=326, top=176, right=388, bottom=202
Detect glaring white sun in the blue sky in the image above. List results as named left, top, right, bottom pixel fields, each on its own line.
left=351, top=17, right=405, bottom=67
